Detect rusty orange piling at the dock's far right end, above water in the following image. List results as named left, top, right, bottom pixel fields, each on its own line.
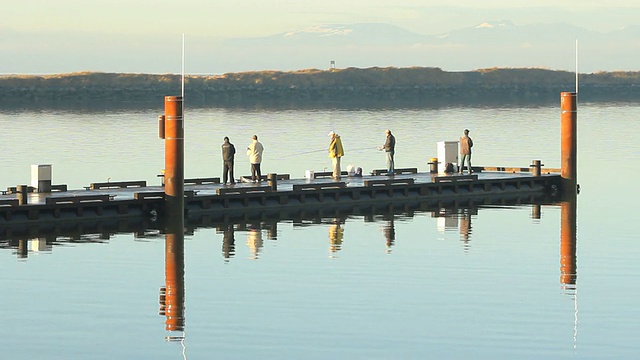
left=560, top=92, right=578, bottom=194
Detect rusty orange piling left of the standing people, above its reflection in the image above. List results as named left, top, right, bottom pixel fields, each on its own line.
left=164, top=96, right=184, bottom=216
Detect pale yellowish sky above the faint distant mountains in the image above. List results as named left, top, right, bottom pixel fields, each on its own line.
left=0, top=0, right=640, bottom=74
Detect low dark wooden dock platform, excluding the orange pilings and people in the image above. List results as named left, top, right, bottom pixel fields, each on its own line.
left=0, top=168, right=561, bottom=237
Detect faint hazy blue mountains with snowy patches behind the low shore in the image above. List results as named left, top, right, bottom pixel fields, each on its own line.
left=212, top=20, right=640, bottom=72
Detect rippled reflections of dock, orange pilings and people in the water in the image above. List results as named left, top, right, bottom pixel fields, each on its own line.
left=0, top=198, right=578, bottom=358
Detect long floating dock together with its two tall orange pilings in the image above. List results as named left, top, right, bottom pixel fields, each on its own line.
left=0, top=92, right=577, bottom=239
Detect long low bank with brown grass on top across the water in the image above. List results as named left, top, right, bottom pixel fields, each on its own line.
left=0, top=67, right=640, bottom=109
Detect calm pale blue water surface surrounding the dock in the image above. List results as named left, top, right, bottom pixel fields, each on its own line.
left=0, top=104, right=640, bottom=359
